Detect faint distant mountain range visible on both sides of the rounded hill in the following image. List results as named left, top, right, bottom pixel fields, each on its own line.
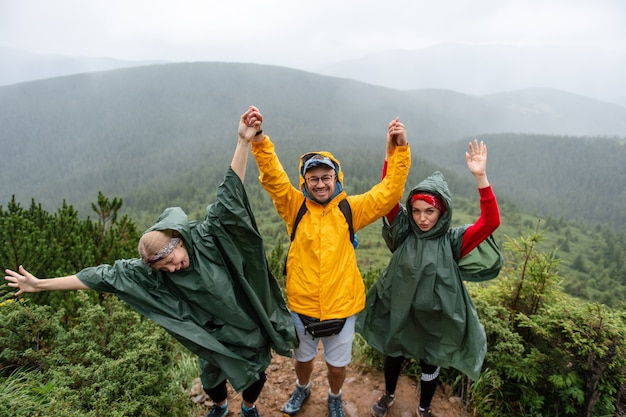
left=0, top=43, right=626, bottom=107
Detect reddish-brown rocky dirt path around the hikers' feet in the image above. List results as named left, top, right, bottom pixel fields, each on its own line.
left=192, top=353, right=466, bottom=417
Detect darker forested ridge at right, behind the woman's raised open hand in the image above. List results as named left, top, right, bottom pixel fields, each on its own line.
left=423, top=133, right=626, bottom=231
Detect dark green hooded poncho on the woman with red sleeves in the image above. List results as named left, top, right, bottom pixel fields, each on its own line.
left=356, top=172, right=487, bottom=379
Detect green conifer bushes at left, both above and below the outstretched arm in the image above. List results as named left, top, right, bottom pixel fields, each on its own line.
left=0, top=193, right=195, bottom=417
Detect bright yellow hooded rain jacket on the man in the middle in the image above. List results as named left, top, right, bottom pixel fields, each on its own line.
left=252, top=136, right=411, bottom=320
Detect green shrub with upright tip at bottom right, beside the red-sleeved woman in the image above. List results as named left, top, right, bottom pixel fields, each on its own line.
left=466, top=232, right=626, bottom=417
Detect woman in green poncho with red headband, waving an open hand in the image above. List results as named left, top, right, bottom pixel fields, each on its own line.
left=356, top=140, right=501, bottom=417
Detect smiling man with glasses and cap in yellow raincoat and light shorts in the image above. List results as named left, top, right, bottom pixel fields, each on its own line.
left=242, top=107, right=411, bottom=417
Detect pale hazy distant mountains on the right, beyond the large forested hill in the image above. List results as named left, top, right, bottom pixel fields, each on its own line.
left=313, top=43, right=626, bottom=106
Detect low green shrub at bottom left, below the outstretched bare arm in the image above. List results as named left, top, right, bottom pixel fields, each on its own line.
left=0, top=292, right=192, bottom=417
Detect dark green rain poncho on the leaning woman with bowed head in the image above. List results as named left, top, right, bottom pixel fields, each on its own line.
left=77, top=169, right=297, bottom=391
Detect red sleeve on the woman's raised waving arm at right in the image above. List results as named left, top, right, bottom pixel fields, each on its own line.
left=461, top=186, right=500, bottom=258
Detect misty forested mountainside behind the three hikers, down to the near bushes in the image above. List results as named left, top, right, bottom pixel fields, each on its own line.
left=0, top=63, right=626, bottom=304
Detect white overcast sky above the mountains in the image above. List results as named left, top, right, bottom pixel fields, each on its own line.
left=0, top=0, right=626, bottom=67
